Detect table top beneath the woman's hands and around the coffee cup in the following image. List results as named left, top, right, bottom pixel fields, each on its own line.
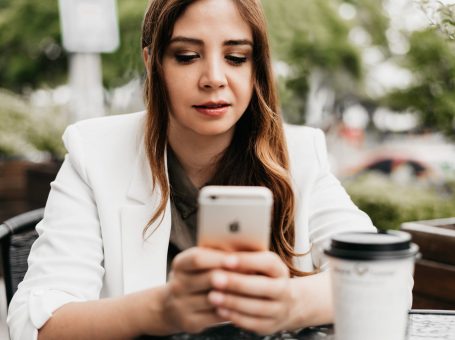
left=138, top=310, right=455, bottom=340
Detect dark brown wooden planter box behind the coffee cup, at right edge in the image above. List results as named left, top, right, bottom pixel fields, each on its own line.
left=401, top=218, right=455, bottom=309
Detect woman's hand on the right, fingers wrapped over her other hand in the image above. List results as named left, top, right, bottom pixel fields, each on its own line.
left=208, top=251, right=298, bottom=334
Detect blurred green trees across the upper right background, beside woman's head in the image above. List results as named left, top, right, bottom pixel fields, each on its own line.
left=263, top=0, right=455, bottom=138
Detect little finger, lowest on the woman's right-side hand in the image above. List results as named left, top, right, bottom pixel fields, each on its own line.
left=217, top=308, right=280, bottom=335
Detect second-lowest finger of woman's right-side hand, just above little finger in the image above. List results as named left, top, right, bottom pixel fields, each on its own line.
left=208, top=290, right=282, bottom=318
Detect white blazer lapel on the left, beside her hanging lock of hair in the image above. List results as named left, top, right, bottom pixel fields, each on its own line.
left=121, top=143, right=171, bottom=294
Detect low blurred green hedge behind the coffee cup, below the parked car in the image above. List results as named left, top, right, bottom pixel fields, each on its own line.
left=343, top=172, right=455, bottom=229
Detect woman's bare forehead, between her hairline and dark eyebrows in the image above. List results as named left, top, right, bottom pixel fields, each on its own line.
left=172, top=0, right=253, bottom=40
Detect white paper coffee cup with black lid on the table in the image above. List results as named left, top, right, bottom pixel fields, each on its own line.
left=324, top=231, right=418, bottom=340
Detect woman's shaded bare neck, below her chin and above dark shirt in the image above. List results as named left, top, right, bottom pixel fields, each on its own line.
left=168, top=126, right=233, bottom=188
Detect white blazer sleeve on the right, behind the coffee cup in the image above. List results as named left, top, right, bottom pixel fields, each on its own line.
left=308, top=129, right=376, bottom=270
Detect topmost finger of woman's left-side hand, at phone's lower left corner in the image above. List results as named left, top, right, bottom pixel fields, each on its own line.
left=172, top=247, right=226, bottom=272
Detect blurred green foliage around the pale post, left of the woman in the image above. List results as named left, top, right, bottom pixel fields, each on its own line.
left=0, top=0, right=146, bottom=158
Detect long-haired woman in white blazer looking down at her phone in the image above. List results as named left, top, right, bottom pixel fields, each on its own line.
left=8, top=0, right=374, bottom=339
